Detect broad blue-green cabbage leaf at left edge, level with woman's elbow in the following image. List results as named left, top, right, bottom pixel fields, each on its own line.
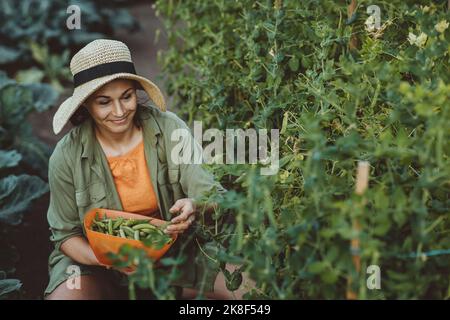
left=0, top=174, right=48, bottom=225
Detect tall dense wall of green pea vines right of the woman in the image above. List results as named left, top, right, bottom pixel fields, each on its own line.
left=152, top=0, right=450, bottom=299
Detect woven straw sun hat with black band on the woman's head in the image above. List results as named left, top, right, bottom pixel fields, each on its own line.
left=53, top=39, right=166, bottom=134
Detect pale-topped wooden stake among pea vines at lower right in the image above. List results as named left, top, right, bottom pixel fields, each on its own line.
left=347, top=161, right=370, bottom=300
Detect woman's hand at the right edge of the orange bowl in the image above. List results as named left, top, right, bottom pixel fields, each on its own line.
left=165, top=198, right=196, bottom=234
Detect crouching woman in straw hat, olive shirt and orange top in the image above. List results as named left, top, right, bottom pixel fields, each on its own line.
left=45, top=40, right=250, bottom=299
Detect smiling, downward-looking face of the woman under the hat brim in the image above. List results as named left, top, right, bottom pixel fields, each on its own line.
left=85, top=79, right=137, bottom=133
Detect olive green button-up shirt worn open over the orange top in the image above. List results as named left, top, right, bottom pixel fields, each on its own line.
left=46, top=107, right=224, bottom=293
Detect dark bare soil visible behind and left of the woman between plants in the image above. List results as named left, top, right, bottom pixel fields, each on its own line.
left=16, top=3, right=170, bottom=299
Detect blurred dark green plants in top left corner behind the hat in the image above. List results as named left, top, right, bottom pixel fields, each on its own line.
left=0, top=0, right=139, bottom=92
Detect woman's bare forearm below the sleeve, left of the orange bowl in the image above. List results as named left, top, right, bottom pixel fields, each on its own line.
left=60, top=236, right=101, bottom=266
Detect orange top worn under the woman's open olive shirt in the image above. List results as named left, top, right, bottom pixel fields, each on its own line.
left=107, top=141, right=158, bottom=215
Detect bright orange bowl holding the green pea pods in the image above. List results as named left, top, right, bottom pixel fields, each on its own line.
left=84, top=208, right=177, bottom=266
